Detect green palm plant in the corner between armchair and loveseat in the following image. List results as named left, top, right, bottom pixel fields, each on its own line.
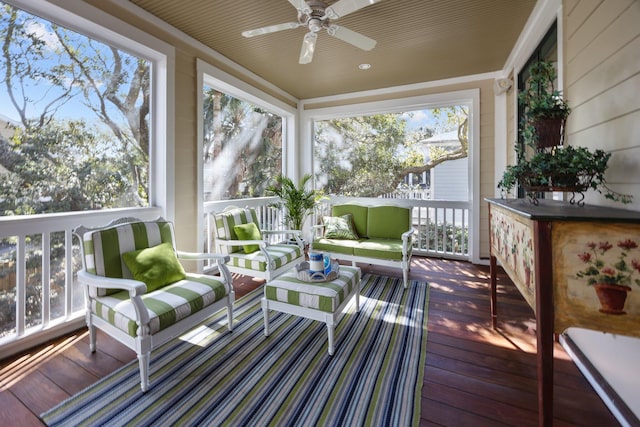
left=267, top=174, right=324, bottom=230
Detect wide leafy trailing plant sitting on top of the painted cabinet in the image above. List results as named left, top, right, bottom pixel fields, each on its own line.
left=498, top=146, right=632, bottom=203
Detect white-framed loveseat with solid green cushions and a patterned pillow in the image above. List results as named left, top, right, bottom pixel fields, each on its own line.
left=311, top=204, right=414, bottom=288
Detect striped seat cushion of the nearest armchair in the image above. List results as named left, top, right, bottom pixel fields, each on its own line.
left=91, top=273, right=227, bottom=337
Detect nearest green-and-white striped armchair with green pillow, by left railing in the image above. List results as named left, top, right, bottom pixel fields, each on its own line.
left=74, top=218, right=235, bottom=392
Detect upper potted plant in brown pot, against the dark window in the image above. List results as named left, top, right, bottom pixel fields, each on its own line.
left=518, top=61, right=571, bottom=148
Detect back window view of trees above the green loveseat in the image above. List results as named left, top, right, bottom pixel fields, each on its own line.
left=313, top=105, right=469, bottom=200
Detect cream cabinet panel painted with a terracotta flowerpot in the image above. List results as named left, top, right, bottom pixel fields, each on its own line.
left=552, top=221, right=640, bottom=336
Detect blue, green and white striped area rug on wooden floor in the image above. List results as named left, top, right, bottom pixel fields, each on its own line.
left=41, top=275, right=429, bottom=426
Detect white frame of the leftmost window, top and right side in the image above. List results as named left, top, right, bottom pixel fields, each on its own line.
left=3, top=0, right=175, bottom=220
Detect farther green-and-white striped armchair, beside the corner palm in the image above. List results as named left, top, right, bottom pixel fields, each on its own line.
left=213, top=207, right=304, bottom=281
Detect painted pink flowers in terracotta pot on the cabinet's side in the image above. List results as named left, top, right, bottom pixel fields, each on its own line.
left=576, top=239, right=640, bottom=315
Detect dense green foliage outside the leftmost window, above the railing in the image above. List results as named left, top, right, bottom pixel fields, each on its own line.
left=0, top=121, right=146, bottom=215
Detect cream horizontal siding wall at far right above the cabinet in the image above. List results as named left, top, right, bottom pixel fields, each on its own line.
left=563, top=0, right=640, bottom=210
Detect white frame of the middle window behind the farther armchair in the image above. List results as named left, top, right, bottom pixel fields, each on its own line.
left=196, top=59, right=297, bottom=258
